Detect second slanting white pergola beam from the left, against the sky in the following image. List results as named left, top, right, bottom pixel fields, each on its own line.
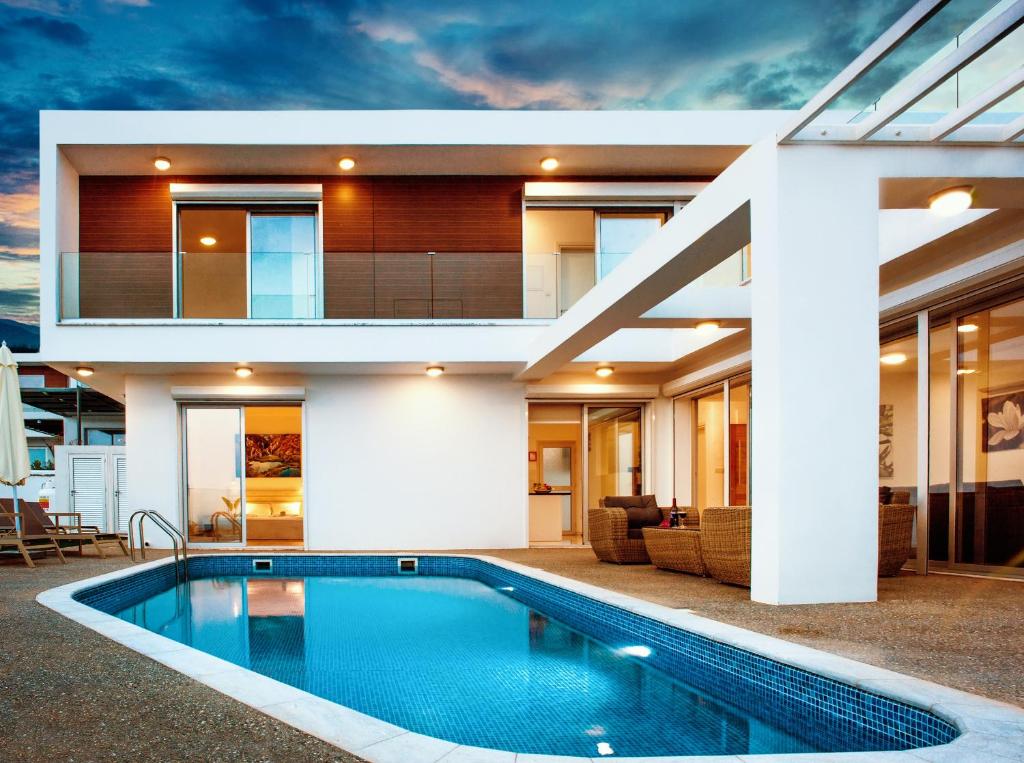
left=854, top=0, right=1024, bottom=141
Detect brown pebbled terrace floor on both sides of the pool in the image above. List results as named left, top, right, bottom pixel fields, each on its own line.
left=0, top=548, right=1024, bottom=761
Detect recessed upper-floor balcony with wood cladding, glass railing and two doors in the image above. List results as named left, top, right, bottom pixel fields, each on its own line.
left=57, top=186, right=750, bottom=324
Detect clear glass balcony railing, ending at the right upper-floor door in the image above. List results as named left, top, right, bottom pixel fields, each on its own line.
left=59, top=252, right=523, bottom=321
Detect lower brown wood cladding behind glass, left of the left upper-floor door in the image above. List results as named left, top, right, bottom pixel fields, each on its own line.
left=78, top=251, right=172, bottom=317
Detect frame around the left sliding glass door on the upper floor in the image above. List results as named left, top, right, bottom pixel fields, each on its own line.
left=171, top=199, right=321, bottom=323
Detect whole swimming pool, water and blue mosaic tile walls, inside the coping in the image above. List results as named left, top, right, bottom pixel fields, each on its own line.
left=61, top=555, right=957, bottom=758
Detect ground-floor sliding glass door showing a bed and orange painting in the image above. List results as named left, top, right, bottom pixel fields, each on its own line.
left=181, top=404, right=305, bottom=547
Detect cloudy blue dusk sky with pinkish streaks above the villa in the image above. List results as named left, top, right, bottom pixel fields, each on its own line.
left=0, top=0, right=981, bottom=323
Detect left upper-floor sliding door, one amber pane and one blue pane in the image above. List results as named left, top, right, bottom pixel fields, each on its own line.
left=178, top=204, right=318, bottom=319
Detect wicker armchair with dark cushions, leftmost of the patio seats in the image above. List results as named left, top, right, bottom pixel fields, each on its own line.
left=587, top=496, right=672, bottom=564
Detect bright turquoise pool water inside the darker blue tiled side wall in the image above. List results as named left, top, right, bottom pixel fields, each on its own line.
left=112, top=577, right=818, bottom=756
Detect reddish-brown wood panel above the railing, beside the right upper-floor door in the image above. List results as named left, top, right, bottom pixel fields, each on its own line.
left=374, top=177, right=522, bottom=252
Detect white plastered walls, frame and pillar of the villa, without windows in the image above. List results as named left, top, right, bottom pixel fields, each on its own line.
left=24, top=102, right=1024, bottom=603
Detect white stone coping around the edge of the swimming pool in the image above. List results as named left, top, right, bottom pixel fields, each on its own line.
left=36, top=552, right=1024, bottom=763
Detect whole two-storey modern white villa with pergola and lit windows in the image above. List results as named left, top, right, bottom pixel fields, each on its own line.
left=20, top=2, right=1024, bottom=604
